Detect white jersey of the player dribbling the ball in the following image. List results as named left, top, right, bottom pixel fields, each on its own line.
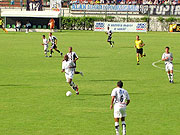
left=62, top=60, right=75, bottom=74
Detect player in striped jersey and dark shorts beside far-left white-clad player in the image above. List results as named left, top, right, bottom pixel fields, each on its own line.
left=48, top=32, right=63, bottom=57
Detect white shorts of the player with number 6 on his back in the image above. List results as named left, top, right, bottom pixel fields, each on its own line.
left=114, top=103, right=126, bottom=118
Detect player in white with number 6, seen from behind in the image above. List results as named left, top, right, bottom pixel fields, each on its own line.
left=110, top=81, right=130, bottom=135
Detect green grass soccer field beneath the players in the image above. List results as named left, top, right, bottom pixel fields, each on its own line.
left=0, top=31, right=180, bottom=135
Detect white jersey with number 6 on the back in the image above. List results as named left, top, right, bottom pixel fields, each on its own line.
left=111, top=88, right=130, bottom=106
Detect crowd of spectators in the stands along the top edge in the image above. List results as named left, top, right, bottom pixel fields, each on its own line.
left=70, top=0, right=180, bottom=5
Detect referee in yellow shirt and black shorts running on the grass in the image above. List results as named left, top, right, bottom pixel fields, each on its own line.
left=134, top=35, right=146, bottom=65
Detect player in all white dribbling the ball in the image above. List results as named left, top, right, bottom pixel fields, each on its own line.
left=61, top=55, right=79, bottom=95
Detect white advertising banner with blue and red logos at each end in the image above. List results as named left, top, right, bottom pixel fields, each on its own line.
left=94, top=22, right=147, bottom=32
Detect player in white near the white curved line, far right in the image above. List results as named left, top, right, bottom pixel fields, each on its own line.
left=162, top=47, right=174, bottom=83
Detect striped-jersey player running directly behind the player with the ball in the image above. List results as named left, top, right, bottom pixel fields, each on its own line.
left=67, top=47, right=83, bottom=76
